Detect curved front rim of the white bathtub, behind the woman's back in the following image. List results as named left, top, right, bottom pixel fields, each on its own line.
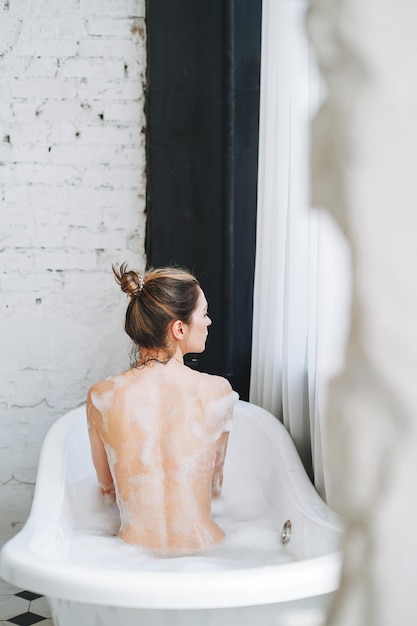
left=0, top=540, right=341, bottom=609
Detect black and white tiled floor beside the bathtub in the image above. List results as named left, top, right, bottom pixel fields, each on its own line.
left=0, top=578, right=53, bottom=626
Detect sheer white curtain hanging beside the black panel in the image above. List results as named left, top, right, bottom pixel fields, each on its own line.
left=250, top=0, right=349, bottom=497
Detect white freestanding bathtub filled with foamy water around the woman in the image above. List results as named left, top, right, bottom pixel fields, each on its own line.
left=0, top=401, right=343, bottom=626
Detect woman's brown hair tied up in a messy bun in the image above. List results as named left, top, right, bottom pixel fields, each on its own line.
left=113, top=263, right=200, bottom=360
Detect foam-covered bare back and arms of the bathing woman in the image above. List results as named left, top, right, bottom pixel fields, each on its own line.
left=87, top=360, right=237, bottom=554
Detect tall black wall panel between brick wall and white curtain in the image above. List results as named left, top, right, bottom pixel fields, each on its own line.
left=146, top=0, right=261, bottom=399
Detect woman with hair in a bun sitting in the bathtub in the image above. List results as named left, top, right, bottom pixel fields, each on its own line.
left=87, top=264, right=238, bottom=555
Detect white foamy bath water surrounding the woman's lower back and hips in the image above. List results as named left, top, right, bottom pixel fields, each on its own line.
left=41, top=468, right=296, bottom=571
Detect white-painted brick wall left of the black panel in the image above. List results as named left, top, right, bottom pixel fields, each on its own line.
left=0, top=0, right=146, bottom=541
